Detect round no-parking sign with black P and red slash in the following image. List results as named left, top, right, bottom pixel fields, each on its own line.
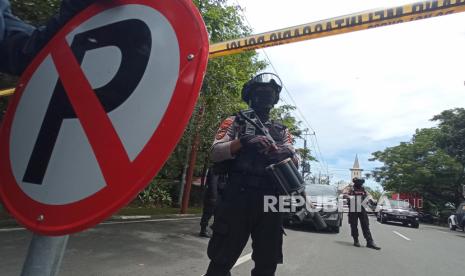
left=0, top=0, right=208, bottom=235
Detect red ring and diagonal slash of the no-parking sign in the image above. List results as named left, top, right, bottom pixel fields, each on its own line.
left=0, top=0, right=208, bottom=235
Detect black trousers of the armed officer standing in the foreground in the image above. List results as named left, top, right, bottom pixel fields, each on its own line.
left=206, top=179, right=284, bottom=276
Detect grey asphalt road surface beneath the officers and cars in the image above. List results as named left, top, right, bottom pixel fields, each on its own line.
left=0, top=218, right=465, bottom=276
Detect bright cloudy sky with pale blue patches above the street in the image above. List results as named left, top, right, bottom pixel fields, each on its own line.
left=231, top=0, right=465, bottom=190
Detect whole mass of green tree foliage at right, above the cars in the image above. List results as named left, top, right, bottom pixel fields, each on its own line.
left=371, top=109, right=465, bottom=209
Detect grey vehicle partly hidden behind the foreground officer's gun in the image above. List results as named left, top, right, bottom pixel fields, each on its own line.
left=285, top=184, right=343, bottom=233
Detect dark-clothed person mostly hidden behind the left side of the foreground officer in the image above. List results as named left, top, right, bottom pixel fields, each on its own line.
left=199, top=166, right=226, bottom=238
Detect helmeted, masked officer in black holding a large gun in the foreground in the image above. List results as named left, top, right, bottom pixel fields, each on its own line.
left=206, top=73, right=295, bottom=276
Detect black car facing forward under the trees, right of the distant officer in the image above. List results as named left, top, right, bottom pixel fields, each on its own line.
left=377, top=200, right=420, bottom=228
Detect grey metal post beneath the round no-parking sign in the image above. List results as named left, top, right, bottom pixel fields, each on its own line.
left=21, top=234, right=69, bottom=276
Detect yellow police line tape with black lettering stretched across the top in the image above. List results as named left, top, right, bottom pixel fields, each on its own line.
left=0, top=0, right=465, bottom=97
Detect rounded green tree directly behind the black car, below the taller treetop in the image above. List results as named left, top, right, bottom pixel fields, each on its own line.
left=370, top=128, right=463, bottom=209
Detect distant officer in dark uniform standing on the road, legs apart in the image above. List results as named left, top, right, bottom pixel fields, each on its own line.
left=348, top=177, right=381, bottom=250
